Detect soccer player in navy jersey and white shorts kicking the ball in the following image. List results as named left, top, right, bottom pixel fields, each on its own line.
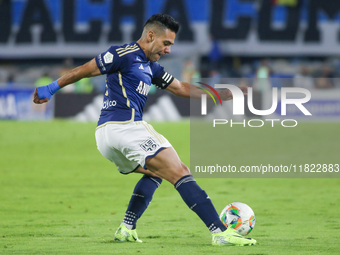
left=33, top=14, right=256, bottom=246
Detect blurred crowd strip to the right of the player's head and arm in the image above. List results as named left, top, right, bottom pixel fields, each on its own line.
left=182, top=38, right=340, bottom=91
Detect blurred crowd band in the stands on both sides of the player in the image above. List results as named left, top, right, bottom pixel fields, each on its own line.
left=0, top=53, right=340, bottom=93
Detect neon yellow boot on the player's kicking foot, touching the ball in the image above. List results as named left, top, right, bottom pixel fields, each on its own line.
left=212, top=227, right=256, bottom=246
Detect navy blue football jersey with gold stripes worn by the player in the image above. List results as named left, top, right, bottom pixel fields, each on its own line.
left=95, top=42, right=173, bottom=126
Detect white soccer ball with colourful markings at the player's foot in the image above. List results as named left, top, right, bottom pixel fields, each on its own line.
left=220, top=202, right=255, bottom=236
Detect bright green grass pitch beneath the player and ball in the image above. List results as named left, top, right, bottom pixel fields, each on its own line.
left=0, top=120, right=340, bottom=255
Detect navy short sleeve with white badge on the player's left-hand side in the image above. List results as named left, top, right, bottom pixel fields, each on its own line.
left=95, top=46, right=125, bottom=74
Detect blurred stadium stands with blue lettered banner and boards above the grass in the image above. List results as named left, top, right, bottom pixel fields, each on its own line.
left=0, top=0, right=340, bottom=121
